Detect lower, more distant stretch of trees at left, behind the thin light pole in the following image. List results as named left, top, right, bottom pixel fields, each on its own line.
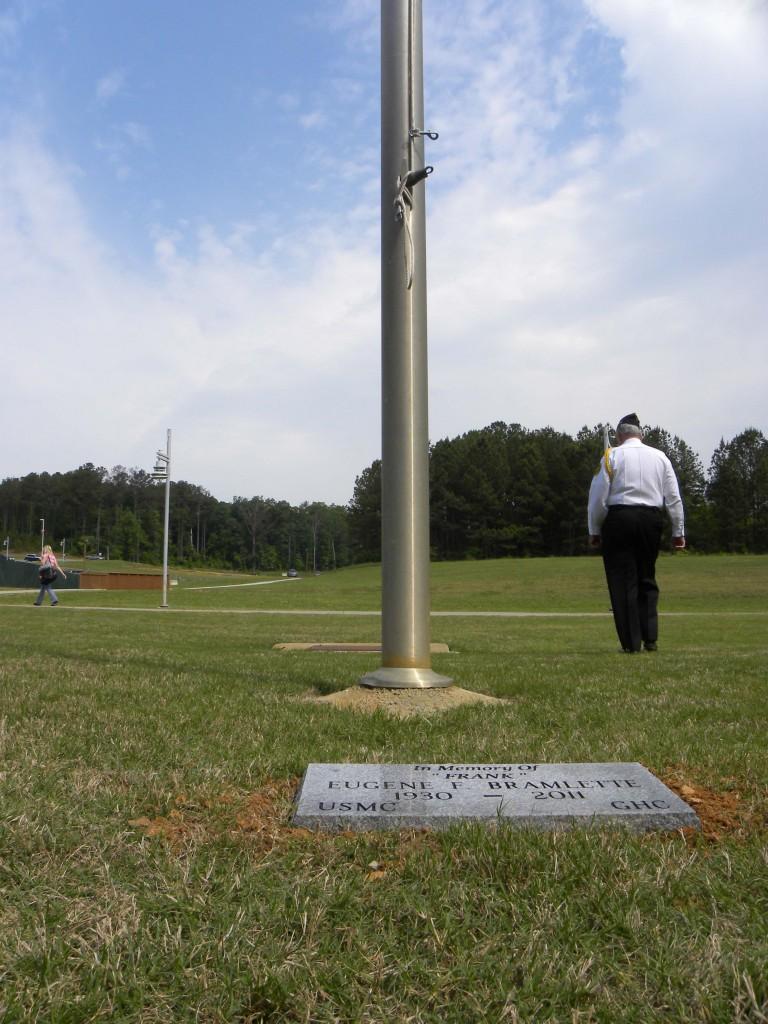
left=0, top=463, right=352, bottom=571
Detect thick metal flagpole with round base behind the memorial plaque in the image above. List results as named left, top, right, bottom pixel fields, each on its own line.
left=360, top=0, right=452, bottom=688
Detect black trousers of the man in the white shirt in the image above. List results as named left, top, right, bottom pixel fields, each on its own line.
left=602, top=505, right=664, bottom=650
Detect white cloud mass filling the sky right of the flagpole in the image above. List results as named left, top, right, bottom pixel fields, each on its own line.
left=421, top=0, right=768, bottom=460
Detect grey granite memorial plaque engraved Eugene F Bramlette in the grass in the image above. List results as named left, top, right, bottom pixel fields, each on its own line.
left=293, top=763, right=700, bottom=831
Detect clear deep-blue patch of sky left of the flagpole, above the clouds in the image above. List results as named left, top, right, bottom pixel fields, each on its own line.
left=6, top=0, right=378, bottom=269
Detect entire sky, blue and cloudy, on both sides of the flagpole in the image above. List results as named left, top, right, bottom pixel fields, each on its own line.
left=0, top=0, right=768, bottom=502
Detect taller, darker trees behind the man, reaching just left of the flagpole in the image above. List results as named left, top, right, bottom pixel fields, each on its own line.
left=348, top=423, right=768, bottom=561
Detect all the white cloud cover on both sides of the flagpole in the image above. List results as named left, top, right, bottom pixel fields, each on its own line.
left=0, top=0, right=768, bottom=502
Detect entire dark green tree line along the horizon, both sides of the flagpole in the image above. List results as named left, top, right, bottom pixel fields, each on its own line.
left=0, top=423, right=768, bottom=571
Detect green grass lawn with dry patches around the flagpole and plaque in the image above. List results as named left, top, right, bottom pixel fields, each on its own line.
left=0, top=554, right=768, bottom=1024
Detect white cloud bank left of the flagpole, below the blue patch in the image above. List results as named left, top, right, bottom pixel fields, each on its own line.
left=0, top=121, right=379, bottom=502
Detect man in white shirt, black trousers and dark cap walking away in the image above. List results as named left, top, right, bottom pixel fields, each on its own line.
left=589, top=413, right=685, bottom=654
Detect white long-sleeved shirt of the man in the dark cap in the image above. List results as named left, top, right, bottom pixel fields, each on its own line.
left=589, top=437, right=684, bottom=537
